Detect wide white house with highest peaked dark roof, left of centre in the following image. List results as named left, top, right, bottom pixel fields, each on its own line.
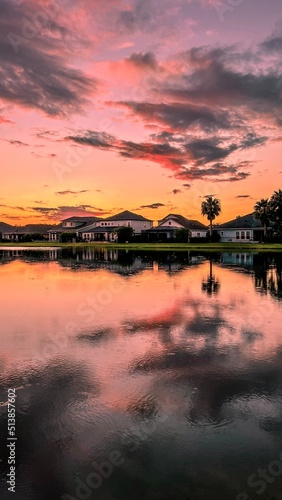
left=76, top=210, right=153, bottom=241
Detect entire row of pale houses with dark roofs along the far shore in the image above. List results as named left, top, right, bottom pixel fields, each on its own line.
left=0, top=210, right=263, bottom=242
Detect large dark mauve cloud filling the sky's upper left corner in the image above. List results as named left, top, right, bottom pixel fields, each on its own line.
left=0, top=0, right=97, bottom=116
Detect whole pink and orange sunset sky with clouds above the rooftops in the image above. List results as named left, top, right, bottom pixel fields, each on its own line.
left=0, top=0, right=282, bottom=225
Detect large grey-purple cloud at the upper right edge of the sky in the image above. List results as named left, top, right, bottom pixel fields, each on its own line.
left=159, top=47, right=282, bottom=121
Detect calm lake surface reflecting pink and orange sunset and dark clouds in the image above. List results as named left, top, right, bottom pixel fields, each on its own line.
left=0, top=249, right=282, bottom=500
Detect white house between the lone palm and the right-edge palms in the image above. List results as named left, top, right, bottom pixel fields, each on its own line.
left=214, top=213, right=263, bottom=243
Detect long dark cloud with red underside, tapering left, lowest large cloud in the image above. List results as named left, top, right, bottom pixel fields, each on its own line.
left=66, top=131, right=256, bottom=181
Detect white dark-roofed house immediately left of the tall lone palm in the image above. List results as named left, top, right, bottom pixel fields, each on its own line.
left=145, top=214, right=207, bottom=239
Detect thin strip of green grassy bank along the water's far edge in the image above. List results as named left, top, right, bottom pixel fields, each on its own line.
left=0, top=241, right=282, bottom=252
